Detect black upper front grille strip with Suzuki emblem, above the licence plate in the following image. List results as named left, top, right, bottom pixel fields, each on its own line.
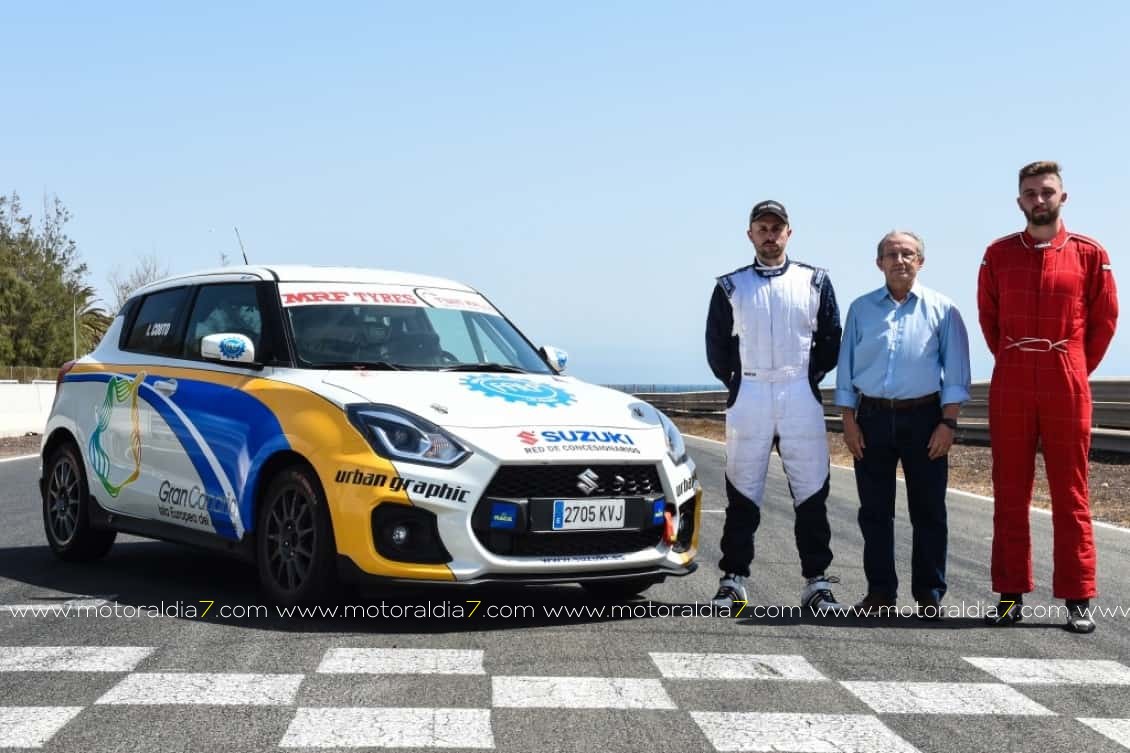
left=483, top=464, right=663, bottom=500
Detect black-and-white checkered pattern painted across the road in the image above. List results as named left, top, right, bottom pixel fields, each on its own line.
left=0, top=646, right=1130, bottom=753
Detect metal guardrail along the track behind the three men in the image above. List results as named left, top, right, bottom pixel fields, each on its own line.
left=635, top=378, right=1130, bottom=455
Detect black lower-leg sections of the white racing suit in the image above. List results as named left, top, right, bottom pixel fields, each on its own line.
left=719, top=478, right=832, bottom=578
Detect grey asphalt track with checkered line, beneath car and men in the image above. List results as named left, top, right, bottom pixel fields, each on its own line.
left=0, top=440, right=1130, bottom=753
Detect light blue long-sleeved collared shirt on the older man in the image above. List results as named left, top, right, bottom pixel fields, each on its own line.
left=836, top=282, right=971, bottom=408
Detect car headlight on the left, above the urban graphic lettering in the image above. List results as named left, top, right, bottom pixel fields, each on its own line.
left=348, top=405, right=471, bottom=468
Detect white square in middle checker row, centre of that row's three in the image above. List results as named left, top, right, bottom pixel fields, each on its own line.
left=490, top=677, right=677, bottom=709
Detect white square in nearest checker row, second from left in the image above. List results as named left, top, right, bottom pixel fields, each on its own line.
left=279, top=708, right=494, bottom=748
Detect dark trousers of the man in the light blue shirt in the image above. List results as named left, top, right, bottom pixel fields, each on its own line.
left=855, top=404, right=949, bottom=600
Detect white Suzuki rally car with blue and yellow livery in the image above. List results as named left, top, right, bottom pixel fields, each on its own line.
left=41, top=266, right=702, bottom=604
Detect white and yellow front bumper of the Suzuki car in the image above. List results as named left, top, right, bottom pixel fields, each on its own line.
left=330, top=456, right=702, bottom=583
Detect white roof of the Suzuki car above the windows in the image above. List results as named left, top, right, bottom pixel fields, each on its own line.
left=130, top=265, right=477, bottom=297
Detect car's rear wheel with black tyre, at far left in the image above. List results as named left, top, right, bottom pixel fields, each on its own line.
left=43, top=442, right=118, bottom=562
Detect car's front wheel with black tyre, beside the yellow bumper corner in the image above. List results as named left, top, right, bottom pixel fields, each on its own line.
left=255, top=466, right=338, bottom=606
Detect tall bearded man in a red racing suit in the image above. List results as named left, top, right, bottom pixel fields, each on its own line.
left=977, top=162, right=1118, bottom=633
